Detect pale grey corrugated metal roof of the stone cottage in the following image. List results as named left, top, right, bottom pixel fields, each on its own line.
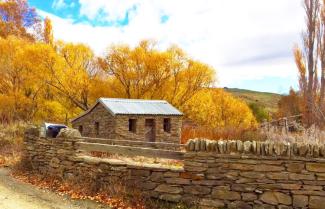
left=98, top=98, right=183, bottom=115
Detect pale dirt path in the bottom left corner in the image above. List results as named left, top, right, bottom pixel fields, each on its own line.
left=0, top=168, right=110, bottom=209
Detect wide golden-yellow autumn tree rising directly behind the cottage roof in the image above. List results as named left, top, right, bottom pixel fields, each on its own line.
left=99, top=40, right=214, bottom=108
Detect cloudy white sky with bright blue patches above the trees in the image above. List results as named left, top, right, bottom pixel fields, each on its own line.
left=28, top=0, right=304, bottom=93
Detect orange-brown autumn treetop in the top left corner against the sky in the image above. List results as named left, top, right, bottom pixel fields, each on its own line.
left=0, top=0, right=40, bottom=40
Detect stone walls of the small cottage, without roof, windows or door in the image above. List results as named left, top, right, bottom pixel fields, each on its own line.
left=72, top=103, right=182, bottom=143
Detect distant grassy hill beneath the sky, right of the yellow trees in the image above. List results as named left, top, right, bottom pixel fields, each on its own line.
left=224, top=87, right=281, bottom=113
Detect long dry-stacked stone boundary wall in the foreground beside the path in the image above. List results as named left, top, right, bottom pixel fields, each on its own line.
left=24, top=130, right=325, bottom=209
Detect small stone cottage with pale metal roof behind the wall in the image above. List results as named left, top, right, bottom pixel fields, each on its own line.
left=71, top=98, right=183, bottom=143
